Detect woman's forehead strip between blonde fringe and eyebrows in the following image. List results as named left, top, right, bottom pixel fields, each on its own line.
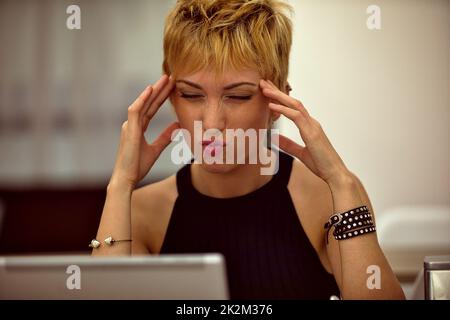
left=176, top=68, right=261, bottom=89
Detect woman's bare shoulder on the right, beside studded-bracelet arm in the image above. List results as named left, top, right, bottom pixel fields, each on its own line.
left=288, top=159, right=333, bottom=272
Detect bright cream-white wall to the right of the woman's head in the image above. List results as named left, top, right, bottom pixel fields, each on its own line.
left=280, top=0, right=450, bottom=212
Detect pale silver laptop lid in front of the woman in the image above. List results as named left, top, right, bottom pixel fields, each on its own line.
left=0, top=253, right=229, bottom=300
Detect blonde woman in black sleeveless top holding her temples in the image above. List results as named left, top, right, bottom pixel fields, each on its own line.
left=91, top=0, right=404, bottom=299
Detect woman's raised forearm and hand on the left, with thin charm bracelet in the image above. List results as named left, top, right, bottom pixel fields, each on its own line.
left=92, top=75, right=178, bottom=256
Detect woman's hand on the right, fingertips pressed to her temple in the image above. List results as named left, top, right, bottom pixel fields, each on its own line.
left=260, top=80, right=351, bottom=184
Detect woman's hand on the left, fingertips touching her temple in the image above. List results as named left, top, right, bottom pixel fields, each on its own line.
left=109, top=75, right=179, bottom=190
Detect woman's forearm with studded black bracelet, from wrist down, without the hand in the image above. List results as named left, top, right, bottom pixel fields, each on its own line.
left=327, top=173, right=405, bottom=299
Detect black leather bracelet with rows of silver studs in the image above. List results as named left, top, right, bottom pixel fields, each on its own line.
left=324, top=206, right=376, bottom=244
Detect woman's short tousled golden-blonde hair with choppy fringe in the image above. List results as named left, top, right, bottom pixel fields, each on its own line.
left=163, top=0, right=293, bottom=90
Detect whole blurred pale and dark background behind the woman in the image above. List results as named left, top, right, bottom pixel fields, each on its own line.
left=0, top=0, right=450, bottom=298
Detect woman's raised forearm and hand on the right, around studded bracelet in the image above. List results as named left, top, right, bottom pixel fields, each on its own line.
left=260, top=80, right=404, bottom=299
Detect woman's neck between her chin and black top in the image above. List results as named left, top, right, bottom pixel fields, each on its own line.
left=191, top=164, right=272, bottom=198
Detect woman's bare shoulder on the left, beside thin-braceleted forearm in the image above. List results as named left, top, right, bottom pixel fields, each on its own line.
left=131, top=175, right=178, bottom=253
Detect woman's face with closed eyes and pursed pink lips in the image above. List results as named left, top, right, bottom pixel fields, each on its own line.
left=171, top=69, right=271, bottom=172
